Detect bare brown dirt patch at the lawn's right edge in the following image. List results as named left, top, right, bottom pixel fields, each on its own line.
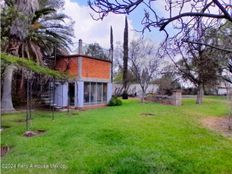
left=201, top=117, right=232, bottom=137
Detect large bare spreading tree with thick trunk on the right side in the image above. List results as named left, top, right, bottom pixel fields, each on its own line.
left=159, top=17, right=232, bottom=104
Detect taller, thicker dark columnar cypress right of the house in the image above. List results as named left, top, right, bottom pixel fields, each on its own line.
left=122, top=17, right=129, bottom=99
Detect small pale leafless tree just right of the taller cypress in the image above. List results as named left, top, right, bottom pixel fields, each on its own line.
left=129, top=39, right=160, bottom=102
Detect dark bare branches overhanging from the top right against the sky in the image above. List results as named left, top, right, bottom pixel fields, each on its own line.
left=89, top=0, right=232, bottom=52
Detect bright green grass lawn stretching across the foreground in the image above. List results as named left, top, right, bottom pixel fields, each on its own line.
left=1, top=97, right=232, bottom=174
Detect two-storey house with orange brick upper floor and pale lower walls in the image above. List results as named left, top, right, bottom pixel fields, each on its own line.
left=54, top=40, right=112, bottom=108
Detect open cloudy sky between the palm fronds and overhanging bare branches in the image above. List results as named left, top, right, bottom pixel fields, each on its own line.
left=64, top=0, right=164, bottom=49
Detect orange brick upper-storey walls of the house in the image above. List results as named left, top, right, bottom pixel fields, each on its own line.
left=56, top=55, right=111, bottom=80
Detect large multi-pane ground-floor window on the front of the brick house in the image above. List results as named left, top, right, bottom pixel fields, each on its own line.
left=84, top=82, right=107, bottom=104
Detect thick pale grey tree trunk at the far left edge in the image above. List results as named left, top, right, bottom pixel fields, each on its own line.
left=1, top=65, right=16, bottom=113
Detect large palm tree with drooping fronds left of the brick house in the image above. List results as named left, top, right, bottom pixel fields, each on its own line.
left=1, top=0, right=72, bottom=112
